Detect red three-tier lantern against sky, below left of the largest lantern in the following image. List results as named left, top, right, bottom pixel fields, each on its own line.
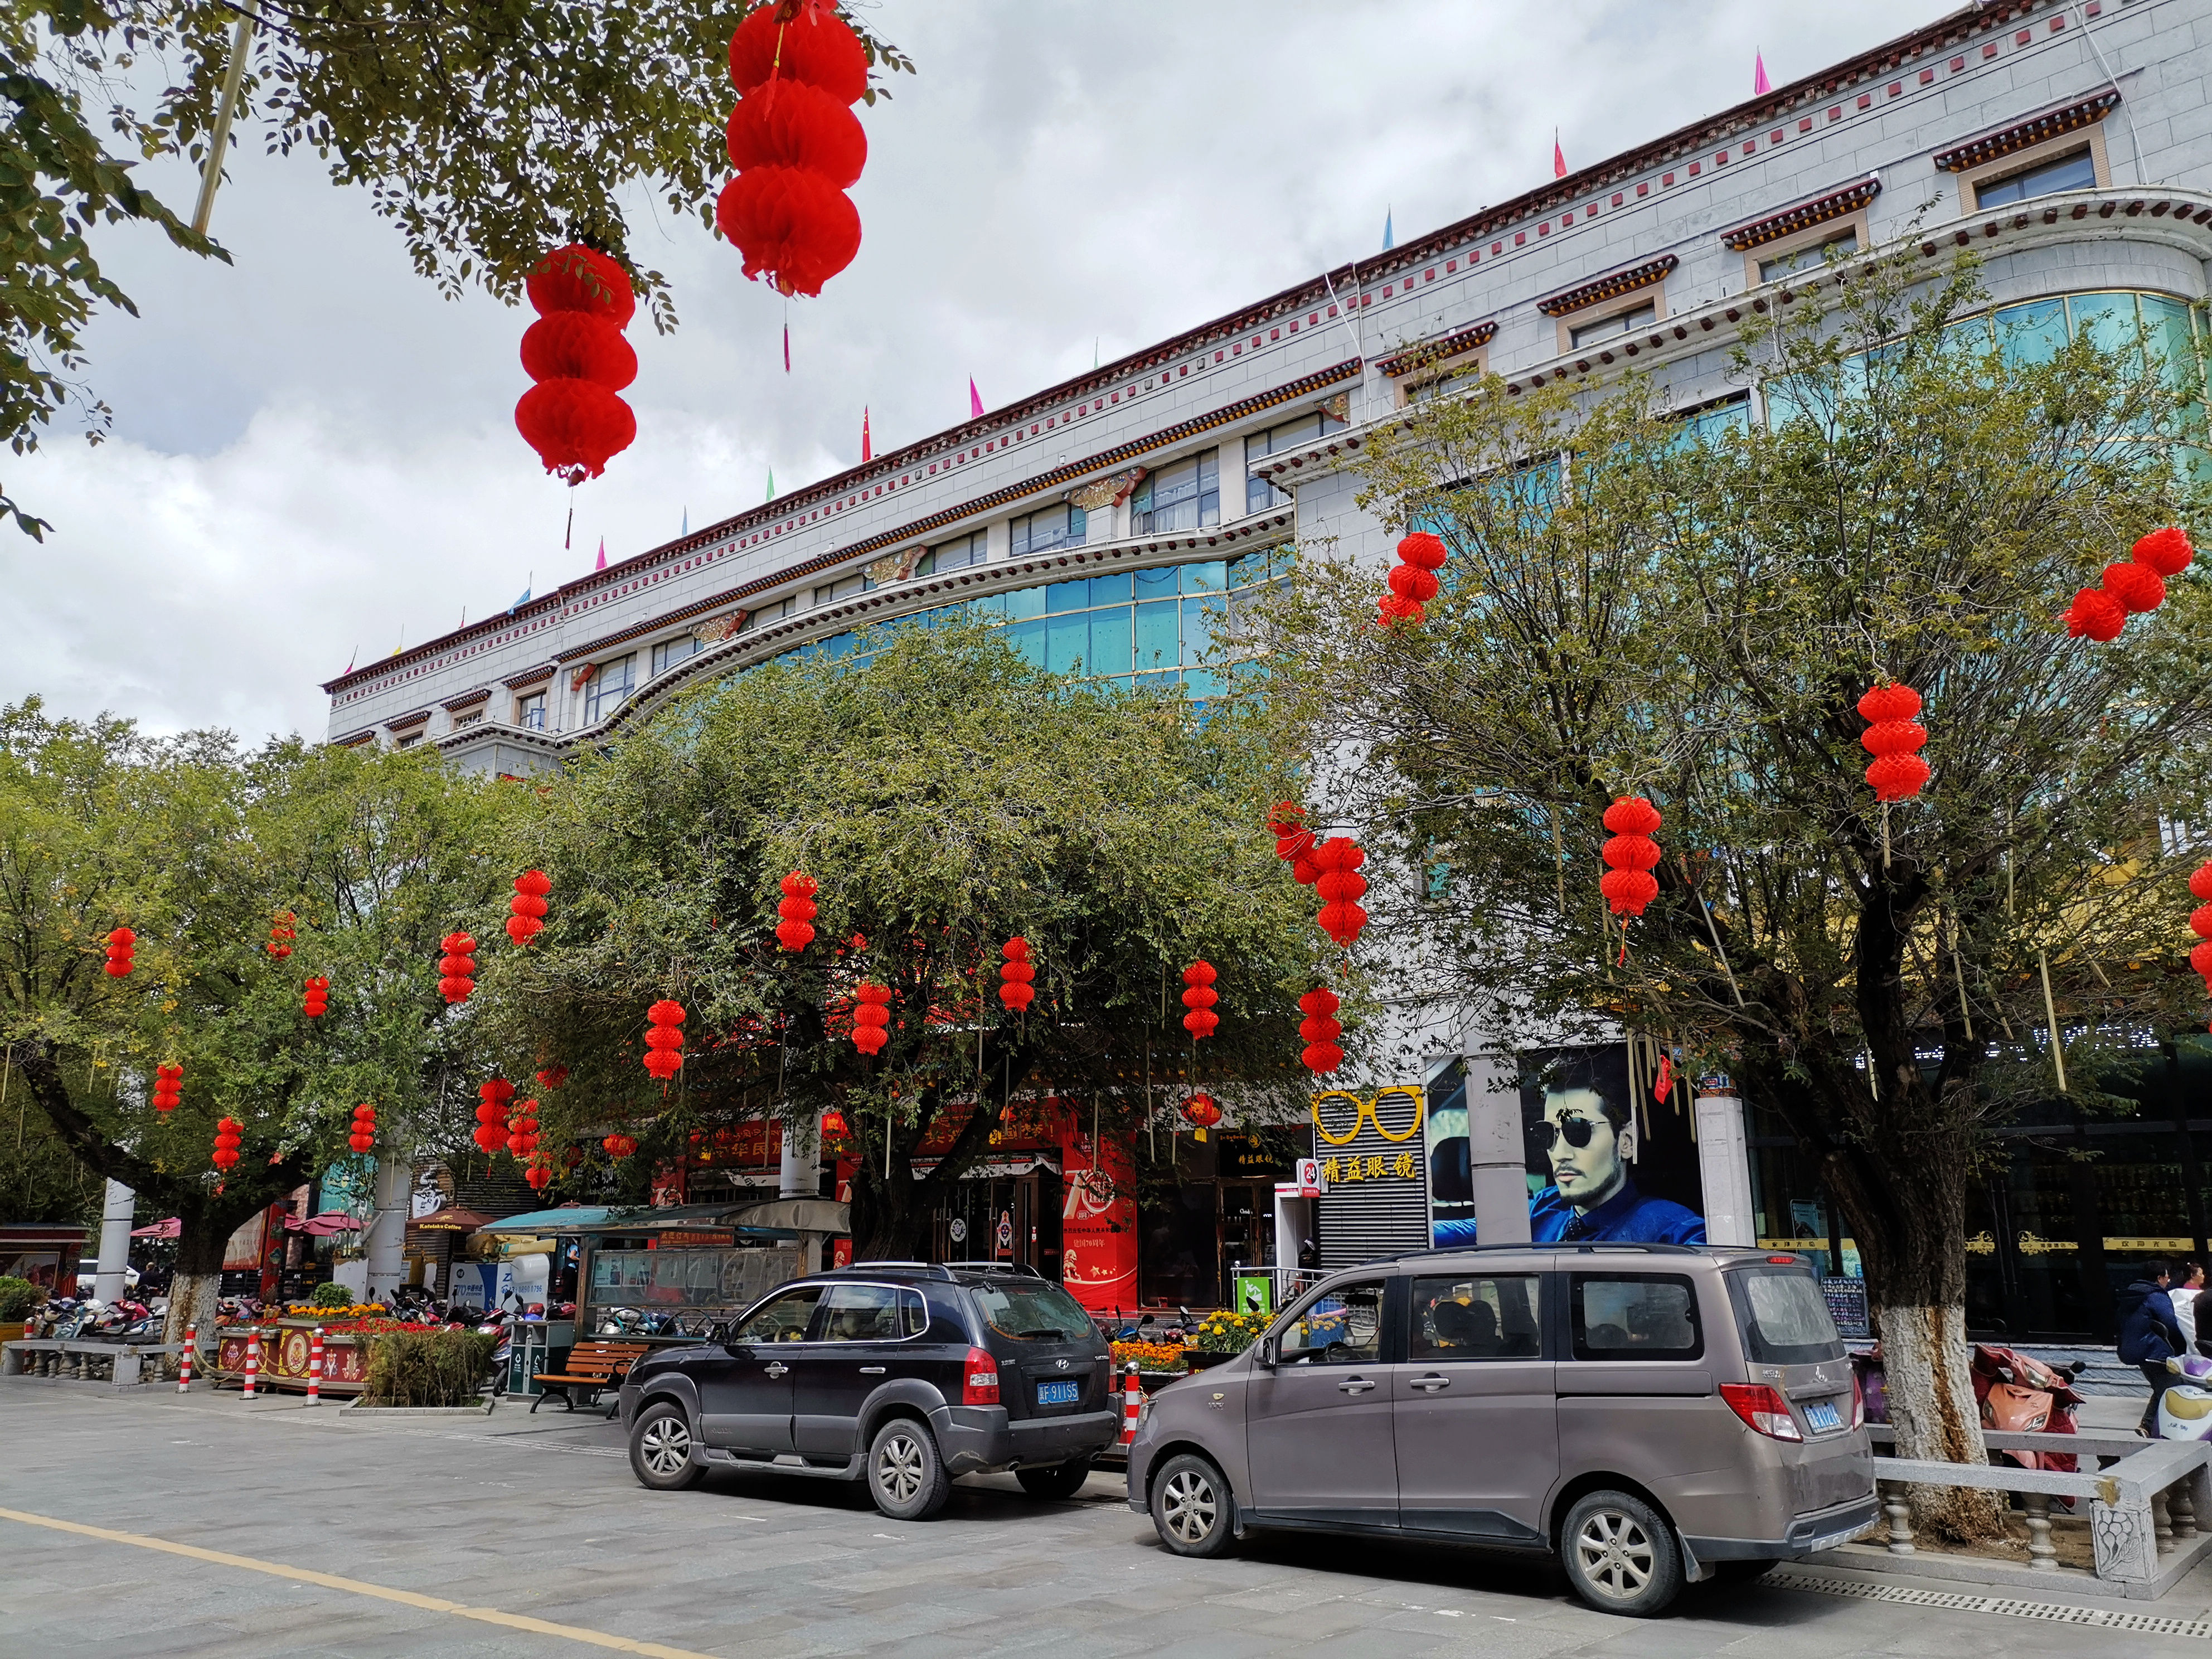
left=516, top=241, right=637, bottom=489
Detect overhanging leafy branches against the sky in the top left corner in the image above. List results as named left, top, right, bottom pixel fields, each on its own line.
left=0, top=0, right=914, bottom=535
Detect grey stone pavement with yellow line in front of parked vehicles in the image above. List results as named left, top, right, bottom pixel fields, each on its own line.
left=0, top=1385, right=2212, bottom=1659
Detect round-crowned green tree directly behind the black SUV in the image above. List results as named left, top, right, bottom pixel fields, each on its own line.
left=484, top=628, right=1321, bottom=1257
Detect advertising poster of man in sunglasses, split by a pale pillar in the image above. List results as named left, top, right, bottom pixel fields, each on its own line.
left=1429, top=1042, right=1705, bottom=1245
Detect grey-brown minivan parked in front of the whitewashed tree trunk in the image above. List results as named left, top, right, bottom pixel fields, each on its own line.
left=1128, top=1243, right=1878, bottom=1615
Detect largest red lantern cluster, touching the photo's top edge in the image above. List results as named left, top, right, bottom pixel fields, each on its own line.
left=715, top=0, right=867, bottom=294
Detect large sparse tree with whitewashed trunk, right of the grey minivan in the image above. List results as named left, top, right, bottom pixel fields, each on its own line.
left=1265, top=248, right=2212, bottom=1533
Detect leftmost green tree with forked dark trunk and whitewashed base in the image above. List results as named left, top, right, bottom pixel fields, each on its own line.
left=0, top=701, right=520, bottom=1330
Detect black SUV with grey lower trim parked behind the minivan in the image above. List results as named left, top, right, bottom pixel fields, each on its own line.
left=622, top=1261, right=1122, bottom=1520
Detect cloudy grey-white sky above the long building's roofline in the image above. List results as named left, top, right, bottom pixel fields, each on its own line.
left=0, top=0, right=1949, bottom=739
